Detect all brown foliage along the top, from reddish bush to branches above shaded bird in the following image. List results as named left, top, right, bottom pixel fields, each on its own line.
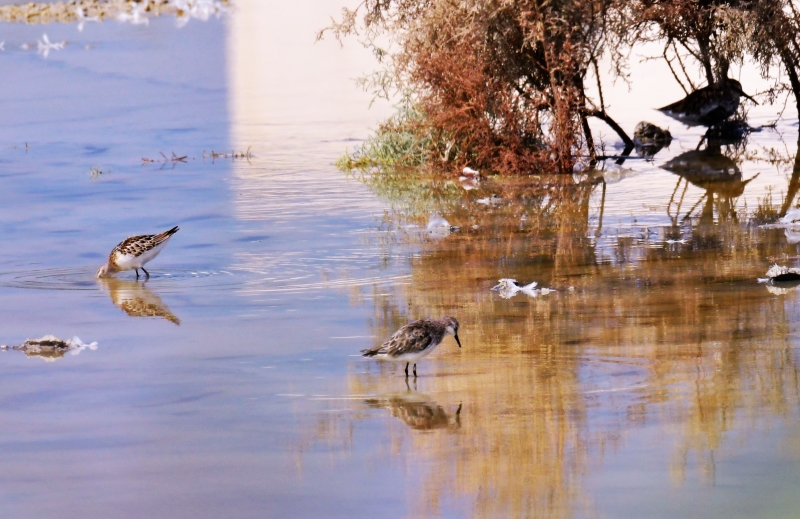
left=330, top=0, right=800, bottom=174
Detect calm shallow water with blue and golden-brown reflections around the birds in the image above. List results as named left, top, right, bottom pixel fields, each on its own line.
left=0, top=0, right=800, bottom=518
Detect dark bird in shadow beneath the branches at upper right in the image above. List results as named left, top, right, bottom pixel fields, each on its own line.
left=659, top=78, right=758, bottom=126
